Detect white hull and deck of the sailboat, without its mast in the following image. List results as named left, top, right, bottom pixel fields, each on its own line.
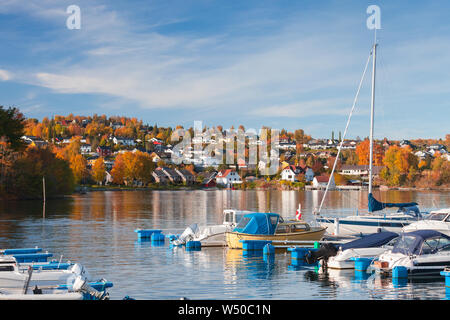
left=316, top=205, right=428, bottom=236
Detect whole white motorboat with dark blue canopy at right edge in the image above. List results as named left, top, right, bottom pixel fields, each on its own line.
left=368, top=230, right=450, bottom=278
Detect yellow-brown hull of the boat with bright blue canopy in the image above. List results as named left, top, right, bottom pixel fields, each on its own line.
left=226, top=228, right=326, bottom=249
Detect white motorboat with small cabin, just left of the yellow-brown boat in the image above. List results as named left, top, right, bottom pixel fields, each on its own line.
left=171, top=209, right=252, bottom=247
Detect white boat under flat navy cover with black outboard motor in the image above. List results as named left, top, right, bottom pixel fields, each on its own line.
left=305, top=231, right=399, bottom=269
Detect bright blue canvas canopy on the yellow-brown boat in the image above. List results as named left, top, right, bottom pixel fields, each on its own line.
left=233, top=212, right=280, bottom=235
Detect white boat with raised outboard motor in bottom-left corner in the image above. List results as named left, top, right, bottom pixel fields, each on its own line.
left=0, top=256, right=90, bottom=289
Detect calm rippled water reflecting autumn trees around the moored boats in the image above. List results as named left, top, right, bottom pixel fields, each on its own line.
left=0, top=190, right=450, bottom=300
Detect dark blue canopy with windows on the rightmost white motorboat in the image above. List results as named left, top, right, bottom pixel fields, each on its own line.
left=392, top=230, right=450, bottom=255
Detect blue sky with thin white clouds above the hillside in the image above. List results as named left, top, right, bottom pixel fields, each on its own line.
left=0, top=0, right=450, bottom=139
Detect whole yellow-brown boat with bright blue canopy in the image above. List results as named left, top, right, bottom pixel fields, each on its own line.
left=226, top=212, right=326, bottom=249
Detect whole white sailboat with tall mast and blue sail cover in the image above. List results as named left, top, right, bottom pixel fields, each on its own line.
left=315, top=33, right=423, bottom=236
